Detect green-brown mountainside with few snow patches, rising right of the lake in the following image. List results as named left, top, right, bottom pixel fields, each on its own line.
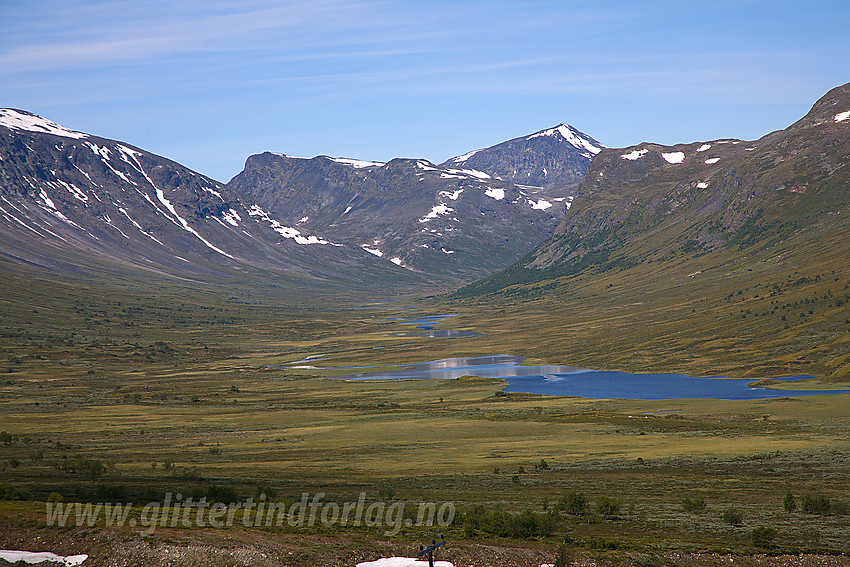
left=444, top=85, right=850, bottom=379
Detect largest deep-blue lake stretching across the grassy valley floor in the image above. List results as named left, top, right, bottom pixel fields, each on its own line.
left=338, top=355, right=850, bottom=400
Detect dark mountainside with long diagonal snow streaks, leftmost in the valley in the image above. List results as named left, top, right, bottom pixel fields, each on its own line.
left=0, top=109, right=404, bottom=288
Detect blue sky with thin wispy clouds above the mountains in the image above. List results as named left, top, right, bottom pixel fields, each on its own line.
left=0, top=0, right=850, bottom=181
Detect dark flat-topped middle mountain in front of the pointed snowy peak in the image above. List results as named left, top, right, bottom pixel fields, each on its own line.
left=228, top=153, right=568, bottom=281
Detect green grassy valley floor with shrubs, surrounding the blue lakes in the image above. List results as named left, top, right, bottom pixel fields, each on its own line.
left=0, top=225, right=850, bottom=566
